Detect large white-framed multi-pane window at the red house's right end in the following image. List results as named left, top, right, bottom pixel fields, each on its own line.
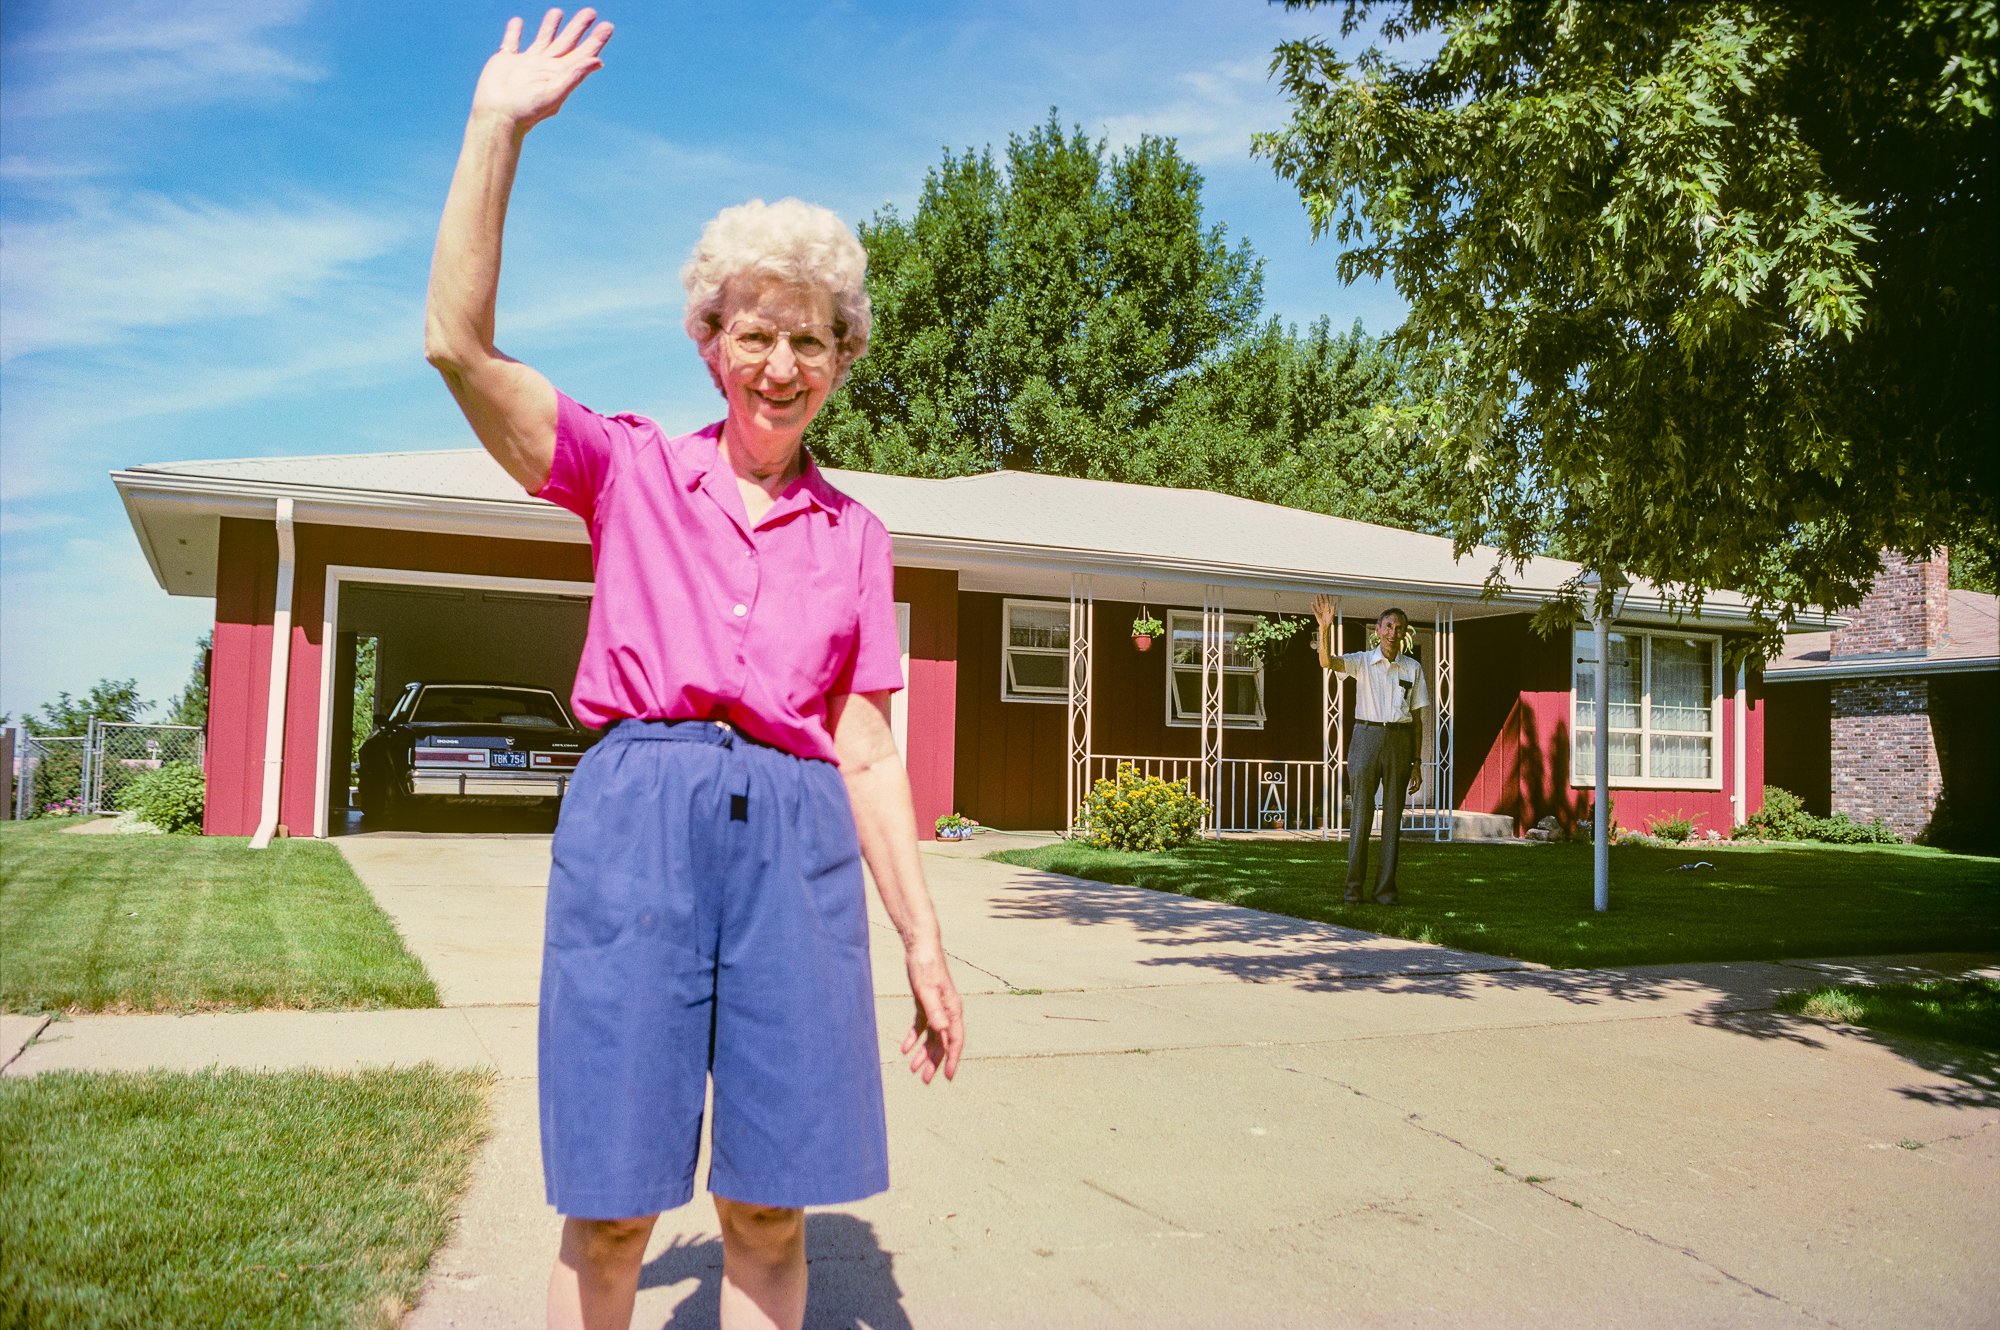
left=1570, top=628, right=1722, bottom=790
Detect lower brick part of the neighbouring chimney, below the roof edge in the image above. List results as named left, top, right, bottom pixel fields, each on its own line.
left=1832, top=674, right=1944, bottom=838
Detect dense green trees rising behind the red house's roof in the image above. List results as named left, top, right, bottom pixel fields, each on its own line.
left=812, top=114, right=1438, bottom=526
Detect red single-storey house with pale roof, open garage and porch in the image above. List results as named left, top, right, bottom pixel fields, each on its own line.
left=114, top=450, right=1764, bottom=836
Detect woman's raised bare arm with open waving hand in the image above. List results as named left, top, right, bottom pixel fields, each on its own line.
left=424, top=8, right=612, bottom=490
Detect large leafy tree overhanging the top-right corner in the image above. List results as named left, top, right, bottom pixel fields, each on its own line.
left=1256, top=0, right=2000, bottom=620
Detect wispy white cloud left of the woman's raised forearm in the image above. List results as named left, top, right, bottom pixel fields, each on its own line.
left=0, top=194, right=406, bottom=362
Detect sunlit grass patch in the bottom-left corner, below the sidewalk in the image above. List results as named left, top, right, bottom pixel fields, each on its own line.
left=0, top=1066, right=492, bottom=1330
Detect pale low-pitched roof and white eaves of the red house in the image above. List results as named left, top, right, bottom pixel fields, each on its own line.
left=112, top=438, right=1748, bottom=628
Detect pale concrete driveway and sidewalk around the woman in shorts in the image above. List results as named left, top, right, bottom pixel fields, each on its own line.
left=0, top=838, right=2000, bottom=1330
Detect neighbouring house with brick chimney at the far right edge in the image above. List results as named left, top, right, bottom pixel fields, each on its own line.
left=1764, top=550, right=2000, bottom=846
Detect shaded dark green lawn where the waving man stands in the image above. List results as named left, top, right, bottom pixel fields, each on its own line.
left=990, top=840, right=2000, bottom=966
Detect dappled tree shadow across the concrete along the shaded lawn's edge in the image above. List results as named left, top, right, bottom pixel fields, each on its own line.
left=996, top=870, right=2000, bottom=1108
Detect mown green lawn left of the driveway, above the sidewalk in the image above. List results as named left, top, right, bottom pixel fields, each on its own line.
left=0, top=820, right=438, bottom=1012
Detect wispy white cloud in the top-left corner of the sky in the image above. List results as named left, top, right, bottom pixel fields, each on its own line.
left=4, top=0, right=326, bottom=118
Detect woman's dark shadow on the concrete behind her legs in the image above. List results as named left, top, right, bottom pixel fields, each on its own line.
left=638, top=1212, right=912, bottom=1330
